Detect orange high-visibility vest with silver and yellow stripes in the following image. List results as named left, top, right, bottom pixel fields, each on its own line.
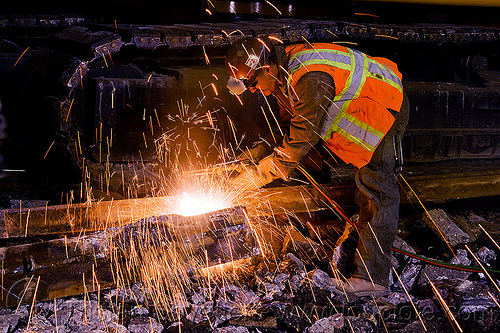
left=285, top=43, right=403, bottom=168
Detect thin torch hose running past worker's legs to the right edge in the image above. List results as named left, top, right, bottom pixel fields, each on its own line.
left=297, top=164, right=500, bottom=274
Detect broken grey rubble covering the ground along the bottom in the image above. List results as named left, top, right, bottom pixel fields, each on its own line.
left=0, top=205, right=500, bottom=333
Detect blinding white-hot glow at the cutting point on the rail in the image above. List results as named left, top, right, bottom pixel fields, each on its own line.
left=174, top=192, right=231, bottom=216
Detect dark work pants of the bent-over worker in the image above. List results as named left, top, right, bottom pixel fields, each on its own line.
left=353, top=94, right=409, bottom=287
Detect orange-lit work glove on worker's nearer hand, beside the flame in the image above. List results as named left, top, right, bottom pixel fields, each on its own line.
left=231, top=154, right=280, bottom=191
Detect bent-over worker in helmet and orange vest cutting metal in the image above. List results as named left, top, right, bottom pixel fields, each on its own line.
left=226, top=37, right=409, bottom=296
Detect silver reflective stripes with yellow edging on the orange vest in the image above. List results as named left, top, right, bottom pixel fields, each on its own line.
left=288, top=44, right=402, bottom=152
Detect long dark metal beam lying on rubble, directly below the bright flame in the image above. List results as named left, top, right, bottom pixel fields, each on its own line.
left=0, top=206, right=261, bottom=308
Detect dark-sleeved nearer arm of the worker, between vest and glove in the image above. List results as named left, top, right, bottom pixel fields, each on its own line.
left=272, top=72, right=335, bottom=179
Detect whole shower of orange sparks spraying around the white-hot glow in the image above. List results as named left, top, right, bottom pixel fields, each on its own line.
left=23, top=46, right=364, bottom=320
